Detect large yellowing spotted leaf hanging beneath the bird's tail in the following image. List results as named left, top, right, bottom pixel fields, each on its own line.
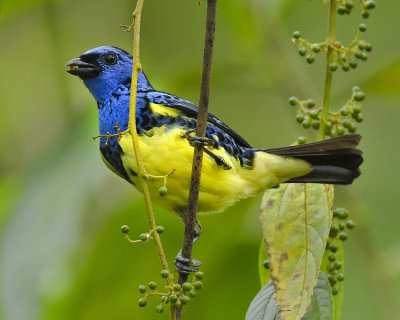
left=260, top=184, right=333, bottom=320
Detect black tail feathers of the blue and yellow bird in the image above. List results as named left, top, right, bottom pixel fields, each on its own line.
left=263, top=134, right=363, bottom=184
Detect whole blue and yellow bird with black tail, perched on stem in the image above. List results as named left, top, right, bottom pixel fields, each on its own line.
left=66, top=46, right=363, bottom=272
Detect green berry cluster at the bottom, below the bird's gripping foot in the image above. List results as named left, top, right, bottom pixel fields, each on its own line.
left=138, top=270, right=204, bottom=313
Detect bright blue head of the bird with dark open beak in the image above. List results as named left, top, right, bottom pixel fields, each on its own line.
left=67, top=46, right=152, bottom=102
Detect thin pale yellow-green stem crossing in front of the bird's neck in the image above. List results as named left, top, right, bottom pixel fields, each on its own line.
left=129, top=0, right=176, bottom=320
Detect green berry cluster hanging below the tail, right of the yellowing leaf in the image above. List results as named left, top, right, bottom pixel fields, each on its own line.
left=326, top=208, right=355, bottom=295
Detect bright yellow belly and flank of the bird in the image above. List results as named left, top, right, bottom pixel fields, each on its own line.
left=119, top=125, right=311, bottom=212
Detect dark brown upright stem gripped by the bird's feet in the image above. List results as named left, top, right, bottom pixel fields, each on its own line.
left=177, top=0, right=217, bottom=319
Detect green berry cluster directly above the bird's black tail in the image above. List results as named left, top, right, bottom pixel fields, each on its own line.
left=289, top=86, right=365, bottom=139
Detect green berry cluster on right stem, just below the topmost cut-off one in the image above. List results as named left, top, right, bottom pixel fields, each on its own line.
left=292, top=23, right=372, bottom=72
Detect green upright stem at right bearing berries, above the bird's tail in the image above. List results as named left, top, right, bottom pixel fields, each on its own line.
left=318, top=0, right=337, bottom=140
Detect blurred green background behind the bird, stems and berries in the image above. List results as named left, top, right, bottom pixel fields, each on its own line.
left=0, top=0, right=400, bottom=320
